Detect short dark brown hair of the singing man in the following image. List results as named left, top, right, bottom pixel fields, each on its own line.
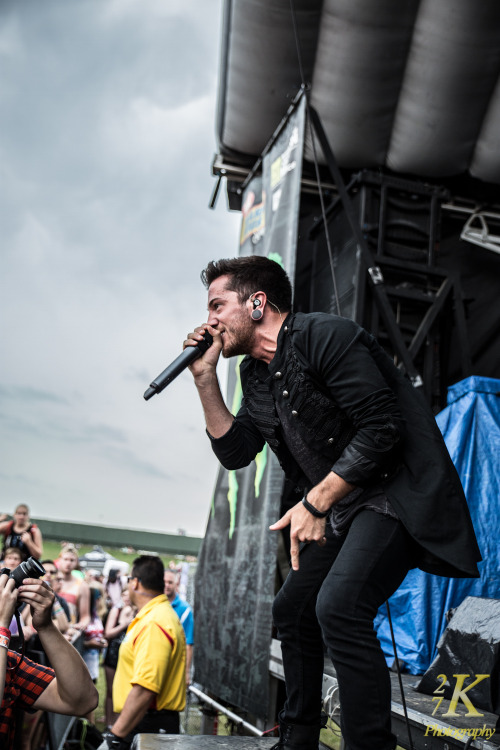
left=201, top=255, right=292, bottom=312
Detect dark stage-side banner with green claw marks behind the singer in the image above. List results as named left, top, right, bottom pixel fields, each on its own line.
left=195, top=98, right=305, bottom=719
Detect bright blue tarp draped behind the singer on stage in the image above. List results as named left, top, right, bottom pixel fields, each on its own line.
left=375, top=377, right=500, bottom=674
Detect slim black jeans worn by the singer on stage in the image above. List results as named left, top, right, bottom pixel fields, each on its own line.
left=273, top=510, right=414, bottom=750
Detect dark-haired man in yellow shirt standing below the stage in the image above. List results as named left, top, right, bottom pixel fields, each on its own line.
left=101, top=555, right=186, bottom=750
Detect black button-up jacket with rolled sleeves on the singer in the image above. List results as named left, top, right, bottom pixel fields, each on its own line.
left=212, top=313, right=481, bottom=577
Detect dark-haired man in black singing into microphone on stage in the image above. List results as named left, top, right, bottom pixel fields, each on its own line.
left=184, top=256, right=480, bottom=750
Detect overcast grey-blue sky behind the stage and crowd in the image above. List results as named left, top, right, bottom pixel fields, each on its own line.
left=0, top=0, right=240, bottom=536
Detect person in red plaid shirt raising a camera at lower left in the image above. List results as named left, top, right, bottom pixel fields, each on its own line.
left=0, top=573, right=99, bottom=748
